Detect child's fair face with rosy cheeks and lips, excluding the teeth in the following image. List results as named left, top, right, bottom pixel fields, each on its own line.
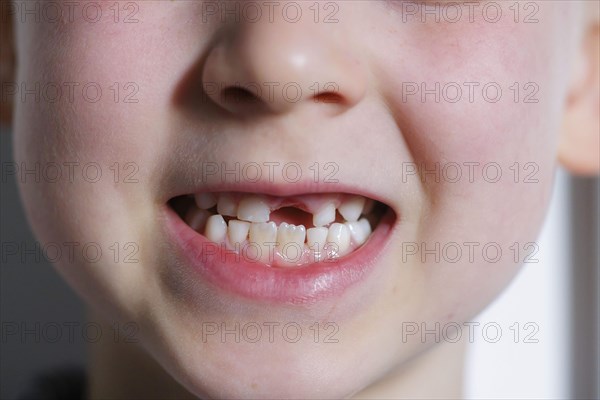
left=14, top=1, right=580, bottom=398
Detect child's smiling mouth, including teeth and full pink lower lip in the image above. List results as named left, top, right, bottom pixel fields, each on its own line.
left=165, top=191, right=397, bottom=304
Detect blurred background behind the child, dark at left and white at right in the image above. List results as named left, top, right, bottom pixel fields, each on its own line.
left=0, top=129, right=600, bottom=399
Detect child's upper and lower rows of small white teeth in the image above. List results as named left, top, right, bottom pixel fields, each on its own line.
left=185, top=193, right=373, bottom=265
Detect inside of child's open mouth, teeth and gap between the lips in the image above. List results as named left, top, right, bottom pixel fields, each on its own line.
left=170, top=192, right=387, bottom=268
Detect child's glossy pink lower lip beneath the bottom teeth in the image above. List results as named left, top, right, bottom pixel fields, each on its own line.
left=165, top=206, right=394, bottom=304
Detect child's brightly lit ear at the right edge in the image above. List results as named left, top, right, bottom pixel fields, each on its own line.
left=558, top=1, right=600, bottom=175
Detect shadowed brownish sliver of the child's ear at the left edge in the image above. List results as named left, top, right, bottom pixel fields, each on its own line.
left=0, top=9, right=15, bottom=125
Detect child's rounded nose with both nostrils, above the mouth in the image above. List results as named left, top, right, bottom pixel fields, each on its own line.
left=202, top=14, right=367, bottom=114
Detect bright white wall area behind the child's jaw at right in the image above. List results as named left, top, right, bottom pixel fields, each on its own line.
left=465, top=170, right=570, bottom=399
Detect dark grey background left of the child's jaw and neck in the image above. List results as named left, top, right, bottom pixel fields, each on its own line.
left=0, top=129, right=86, bottom=399
